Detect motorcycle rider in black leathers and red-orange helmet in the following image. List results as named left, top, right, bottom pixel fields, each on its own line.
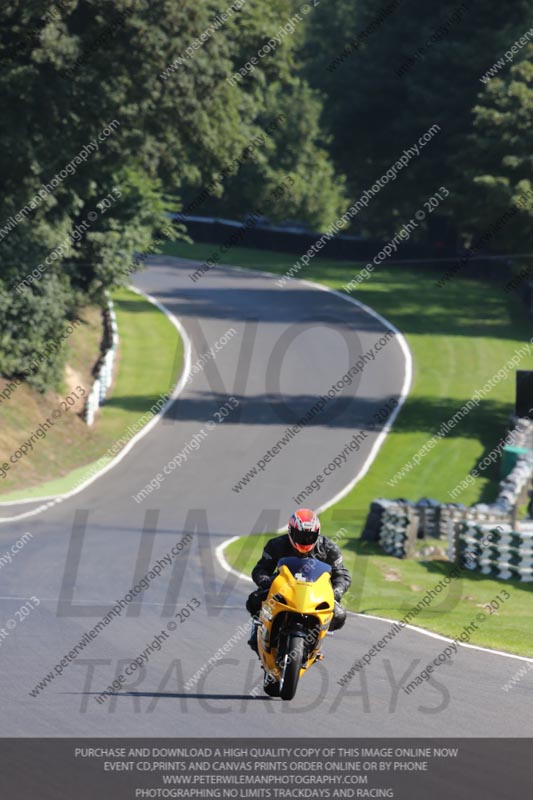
left=246, top=508, right=352, bottom=653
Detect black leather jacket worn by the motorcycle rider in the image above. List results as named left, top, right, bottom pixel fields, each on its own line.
left=252, top=533, right=352, bottom=598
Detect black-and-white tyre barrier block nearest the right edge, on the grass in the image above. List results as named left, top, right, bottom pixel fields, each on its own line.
left=449, top=522, right=533, bottom=582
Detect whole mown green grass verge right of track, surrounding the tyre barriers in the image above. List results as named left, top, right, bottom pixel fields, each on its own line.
left=166, top=238, right=533, bottom=656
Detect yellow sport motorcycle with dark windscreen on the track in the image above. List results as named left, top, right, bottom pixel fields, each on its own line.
left=257, top=556, right=335, bottom=700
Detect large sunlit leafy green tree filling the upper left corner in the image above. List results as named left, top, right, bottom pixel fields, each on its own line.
left=0, top=0, right=340, bottom=386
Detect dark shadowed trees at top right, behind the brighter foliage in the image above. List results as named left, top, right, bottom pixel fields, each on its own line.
left=302, top=0, right=531, bottom=244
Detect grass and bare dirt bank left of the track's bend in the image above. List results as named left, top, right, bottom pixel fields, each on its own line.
left=0, top=289, right=183, bottom=502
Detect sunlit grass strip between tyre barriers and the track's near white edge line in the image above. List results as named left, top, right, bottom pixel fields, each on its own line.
left=225, top=532, right=533, bottom=657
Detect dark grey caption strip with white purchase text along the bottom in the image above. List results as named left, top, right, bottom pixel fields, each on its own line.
left=0, top=736, right=533, bottom=800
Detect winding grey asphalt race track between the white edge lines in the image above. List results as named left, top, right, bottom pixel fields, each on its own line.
left=0, top=257, right=533, bottom=737
